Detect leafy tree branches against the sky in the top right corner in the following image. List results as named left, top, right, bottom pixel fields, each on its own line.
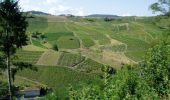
left=150, top=0, right=170, bottom=16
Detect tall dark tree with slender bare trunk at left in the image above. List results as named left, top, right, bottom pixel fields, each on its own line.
left=0, top=0, right=28, bottom=100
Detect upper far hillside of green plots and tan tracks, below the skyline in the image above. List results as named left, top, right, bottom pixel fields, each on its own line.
left=24, top=16, right=165, bottom=67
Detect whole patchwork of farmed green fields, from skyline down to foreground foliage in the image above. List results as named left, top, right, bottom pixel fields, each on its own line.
left=0, top=0, right=170, bottom=100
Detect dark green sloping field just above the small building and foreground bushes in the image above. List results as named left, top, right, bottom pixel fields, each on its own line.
left=17, top=66, right=100, bottom=99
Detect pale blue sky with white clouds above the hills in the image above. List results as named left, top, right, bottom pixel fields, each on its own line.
left=19, top=0, right=158, bottom=16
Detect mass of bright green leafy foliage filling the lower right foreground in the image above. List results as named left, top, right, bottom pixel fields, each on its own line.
left=66, top=43, right=170, bottom=100
